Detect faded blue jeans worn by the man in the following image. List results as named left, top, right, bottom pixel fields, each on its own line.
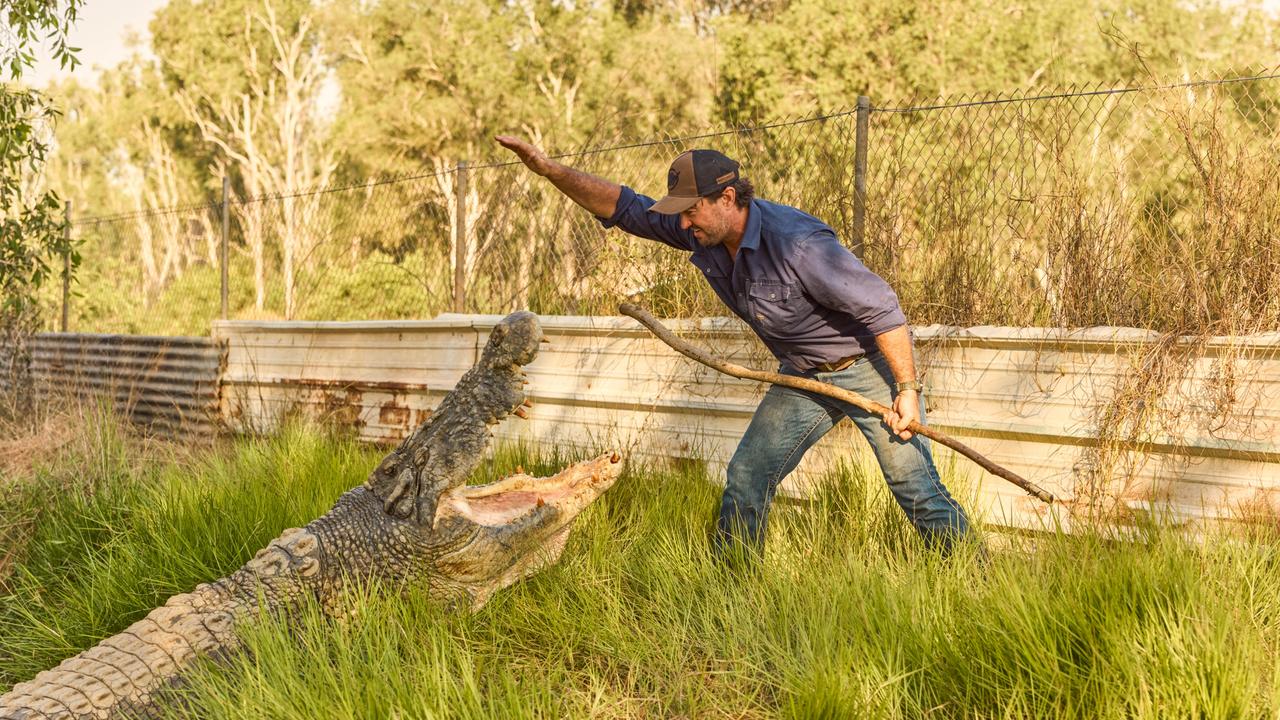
left=714, top=354, right=969, bottom=552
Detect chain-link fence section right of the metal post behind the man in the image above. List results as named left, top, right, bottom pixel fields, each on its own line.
left=867, top=73, right=1280, bottom=333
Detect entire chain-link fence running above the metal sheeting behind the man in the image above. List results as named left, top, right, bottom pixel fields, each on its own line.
left=49, top=69, right=1280, bottom=334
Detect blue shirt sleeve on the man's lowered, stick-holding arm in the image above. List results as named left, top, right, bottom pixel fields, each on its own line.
left=792, top=232, right=906, bottom=334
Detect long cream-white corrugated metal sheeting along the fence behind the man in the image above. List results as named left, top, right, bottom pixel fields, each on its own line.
left=215, top=315, right=1280, bottom=527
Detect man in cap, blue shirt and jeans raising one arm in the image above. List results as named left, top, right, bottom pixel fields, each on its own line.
left=497, top=136, right=969, bottom=552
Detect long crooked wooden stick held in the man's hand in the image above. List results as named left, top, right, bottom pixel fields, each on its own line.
left=618, top=302, right=1053, bottom=503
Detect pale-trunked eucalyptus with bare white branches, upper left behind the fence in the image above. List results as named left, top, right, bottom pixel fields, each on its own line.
left=151, top=0, right=337, bottom=318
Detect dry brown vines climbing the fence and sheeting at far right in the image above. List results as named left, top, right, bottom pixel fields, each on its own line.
left=1065, top=65, right=1280, bottom=515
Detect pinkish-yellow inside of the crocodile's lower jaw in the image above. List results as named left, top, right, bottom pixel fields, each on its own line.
left=442, top=452, right=622, bottom=528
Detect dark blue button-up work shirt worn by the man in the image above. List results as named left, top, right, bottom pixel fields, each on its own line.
left=598, top=186, right=906, bottom=372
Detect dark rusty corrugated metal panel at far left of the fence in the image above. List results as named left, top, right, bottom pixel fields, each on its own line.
left=31, top=333, right=223, bottom=439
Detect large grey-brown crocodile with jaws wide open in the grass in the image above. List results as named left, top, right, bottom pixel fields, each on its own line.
left=0, top=311, right=622, bottom=720
